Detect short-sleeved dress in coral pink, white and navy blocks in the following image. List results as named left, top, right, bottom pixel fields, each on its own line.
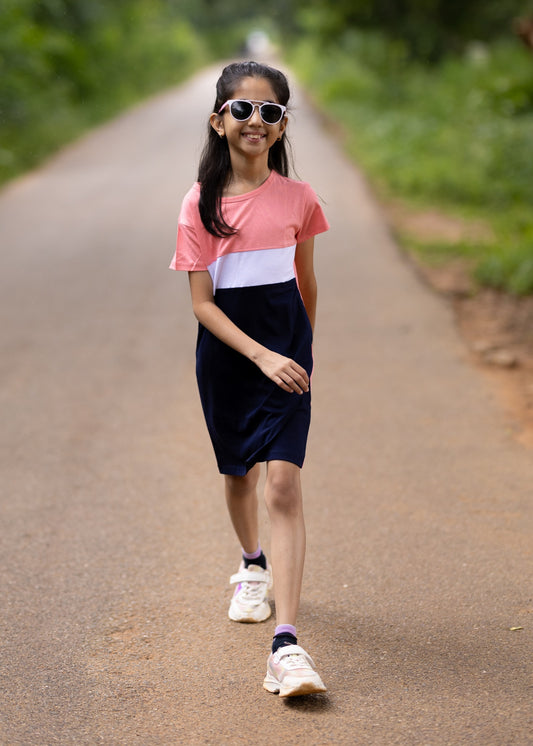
left=170, top=171, right=329, bottom=476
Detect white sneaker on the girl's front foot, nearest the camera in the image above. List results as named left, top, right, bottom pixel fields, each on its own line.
left=263, top=645, right=327, bottom=697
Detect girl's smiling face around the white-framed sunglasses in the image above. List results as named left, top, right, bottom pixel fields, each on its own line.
left=210, top=78, right=287, bottom=158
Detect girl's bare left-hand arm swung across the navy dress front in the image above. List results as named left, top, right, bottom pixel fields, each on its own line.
left=189, top=271, right=309, bottom=394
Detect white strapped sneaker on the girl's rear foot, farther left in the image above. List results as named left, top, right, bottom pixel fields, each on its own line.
left=228, top=562, right=272, bottom=622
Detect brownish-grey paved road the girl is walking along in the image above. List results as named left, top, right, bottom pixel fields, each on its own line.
left=0, top=65, right=533, bottom=746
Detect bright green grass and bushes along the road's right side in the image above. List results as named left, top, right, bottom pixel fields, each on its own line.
left=289, top=33, right=533, bottom=295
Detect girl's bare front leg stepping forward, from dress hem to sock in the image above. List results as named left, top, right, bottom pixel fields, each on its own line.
left=265, top=461, right=305, bottom=625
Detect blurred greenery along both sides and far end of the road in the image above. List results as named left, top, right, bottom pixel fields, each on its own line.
left=0, top=0, right=533, bottom=295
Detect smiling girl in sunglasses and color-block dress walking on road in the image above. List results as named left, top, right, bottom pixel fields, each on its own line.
left=170, top=62, right=329, bottom=697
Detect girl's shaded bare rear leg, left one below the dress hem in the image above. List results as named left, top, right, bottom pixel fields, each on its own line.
left=224, top=464, right=260, bottom=553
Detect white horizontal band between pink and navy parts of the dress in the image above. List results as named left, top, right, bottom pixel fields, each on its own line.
left=207, top=244, right=296, bottom=291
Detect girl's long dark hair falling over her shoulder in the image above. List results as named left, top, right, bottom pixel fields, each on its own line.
left=198, top=62, right=290, bottom=238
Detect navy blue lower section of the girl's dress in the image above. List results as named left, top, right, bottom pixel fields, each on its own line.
left=196, top=279, right=313, bottom=476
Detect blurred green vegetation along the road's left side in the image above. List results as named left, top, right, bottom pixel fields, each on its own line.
left=0, top=0, right=208, bottom=183
